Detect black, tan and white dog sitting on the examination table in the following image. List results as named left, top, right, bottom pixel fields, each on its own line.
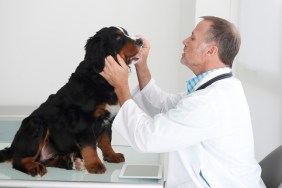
left=0, top=26, right=143, bottom=177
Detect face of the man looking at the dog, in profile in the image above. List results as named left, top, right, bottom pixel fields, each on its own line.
left=181, top=20, right=211, bottom=74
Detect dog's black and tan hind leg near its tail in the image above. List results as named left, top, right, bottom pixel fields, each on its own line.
left=12, top=119, right=49, bottom=176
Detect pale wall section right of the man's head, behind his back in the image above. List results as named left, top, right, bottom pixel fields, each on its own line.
left=236, top=0, right=282, bottom=160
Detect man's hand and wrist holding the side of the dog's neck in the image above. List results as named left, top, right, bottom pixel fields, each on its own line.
left=100, top=55, right=131, bottom=105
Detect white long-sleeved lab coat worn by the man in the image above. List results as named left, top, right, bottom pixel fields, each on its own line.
left=113, top=68, right=265, bottom=188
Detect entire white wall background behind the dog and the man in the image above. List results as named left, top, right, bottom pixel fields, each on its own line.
left=0, top=0, right=282, bottom=160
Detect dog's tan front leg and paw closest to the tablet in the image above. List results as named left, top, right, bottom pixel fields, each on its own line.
left=97, top=130, right=125, bottom=163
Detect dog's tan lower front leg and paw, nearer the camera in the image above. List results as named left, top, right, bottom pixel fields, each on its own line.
left=81, top=146, right=106, bottom=174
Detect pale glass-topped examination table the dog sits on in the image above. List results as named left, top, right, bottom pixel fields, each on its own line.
left=0, top=120, right=163, bottom=188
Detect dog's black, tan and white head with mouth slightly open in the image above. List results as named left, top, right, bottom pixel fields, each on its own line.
left=84, top=27, right=143, bottom=72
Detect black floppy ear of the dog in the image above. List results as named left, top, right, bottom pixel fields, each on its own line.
left=84, top=34, right=106, bottom=73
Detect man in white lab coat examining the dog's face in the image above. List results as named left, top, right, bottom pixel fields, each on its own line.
left=100, top=16, right=265, bottom=188
